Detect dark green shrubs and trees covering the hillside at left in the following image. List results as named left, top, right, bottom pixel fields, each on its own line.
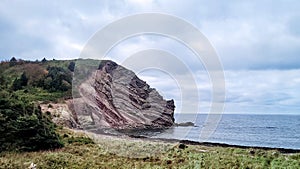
left=0, top=58, right=74, bottom=151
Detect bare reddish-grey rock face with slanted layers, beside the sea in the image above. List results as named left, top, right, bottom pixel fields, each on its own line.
left=73, top=61, right=175, bottom=129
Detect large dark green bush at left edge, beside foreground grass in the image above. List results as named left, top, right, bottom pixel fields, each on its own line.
left=0, top=92, right=63, bottom=151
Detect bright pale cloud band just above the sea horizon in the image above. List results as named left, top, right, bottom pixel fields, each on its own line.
left=135, top=70, right=300, bottom=114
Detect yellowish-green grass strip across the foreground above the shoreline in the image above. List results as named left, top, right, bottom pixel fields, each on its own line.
left=0, top=131, right=300, bottom=169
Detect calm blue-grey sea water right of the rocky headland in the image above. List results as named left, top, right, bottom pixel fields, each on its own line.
left=152, top=114, right=300, bottom=149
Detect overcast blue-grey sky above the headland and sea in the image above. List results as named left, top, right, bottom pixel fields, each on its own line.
left=0, top=0, right=300, bottom=115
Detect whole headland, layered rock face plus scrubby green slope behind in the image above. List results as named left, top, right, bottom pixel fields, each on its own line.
left=0, top=59, right=175, bottom=133
